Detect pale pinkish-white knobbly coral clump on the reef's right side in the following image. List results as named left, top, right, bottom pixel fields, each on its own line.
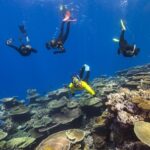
left=106, top=89, right=147, bottom=125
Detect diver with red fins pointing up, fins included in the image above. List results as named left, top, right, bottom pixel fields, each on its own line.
left=45, top=11, right=76, bottom=54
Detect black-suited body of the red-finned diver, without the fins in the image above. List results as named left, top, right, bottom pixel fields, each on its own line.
left=46, top=21, right=70, bottom=54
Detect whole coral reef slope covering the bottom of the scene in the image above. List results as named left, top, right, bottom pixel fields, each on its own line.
left=0, top=64, right=150, bottom=150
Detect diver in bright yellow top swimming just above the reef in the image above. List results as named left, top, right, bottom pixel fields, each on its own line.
left=69, top=64, right=95, bottom=96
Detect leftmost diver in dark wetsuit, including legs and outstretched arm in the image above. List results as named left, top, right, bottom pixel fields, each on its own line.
left=6, top=25, right=37, bottom=56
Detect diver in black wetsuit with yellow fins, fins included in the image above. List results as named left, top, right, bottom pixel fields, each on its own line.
left=113, top=20, right=140, bottom=57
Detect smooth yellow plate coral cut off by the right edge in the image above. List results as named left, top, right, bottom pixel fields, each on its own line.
left=134, top=121, right=150, bottom=146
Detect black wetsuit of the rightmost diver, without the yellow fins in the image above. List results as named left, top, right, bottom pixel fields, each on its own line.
left=118, top=30, right=139, bottom=57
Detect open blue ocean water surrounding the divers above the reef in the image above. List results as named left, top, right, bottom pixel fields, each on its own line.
left=0, top=0, right=150, bottom=98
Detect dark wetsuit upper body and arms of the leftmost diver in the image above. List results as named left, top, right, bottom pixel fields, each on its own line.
left=8, top=44, right=37, bottom=56
